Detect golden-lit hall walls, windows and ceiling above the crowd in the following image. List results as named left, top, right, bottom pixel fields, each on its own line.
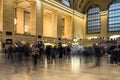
left=0, top=0, right=120, bottom=45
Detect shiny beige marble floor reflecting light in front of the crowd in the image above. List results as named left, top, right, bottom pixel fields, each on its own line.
left=0, top=56, right=120, bottom=80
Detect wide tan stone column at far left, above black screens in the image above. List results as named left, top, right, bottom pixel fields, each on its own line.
left=3, top=0, right=15, bottom=43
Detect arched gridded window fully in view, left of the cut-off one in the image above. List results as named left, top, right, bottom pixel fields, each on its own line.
left=87, top=6, right=100, bottom=33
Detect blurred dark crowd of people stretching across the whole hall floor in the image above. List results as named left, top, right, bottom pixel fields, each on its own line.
left=3, top=43, right=120, bottom=71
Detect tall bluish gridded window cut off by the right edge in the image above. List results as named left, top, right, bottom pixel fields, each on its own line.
left=108, top=0, right=120, bottom=32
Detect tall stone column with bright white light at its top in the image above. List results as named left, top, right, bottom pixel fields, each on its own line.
left=31, top=1, right=43, bottom=41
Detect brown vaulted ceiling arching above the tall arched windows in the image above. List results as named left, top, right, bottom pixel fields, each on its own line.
left=56, top=0, right=112, bottom=13
